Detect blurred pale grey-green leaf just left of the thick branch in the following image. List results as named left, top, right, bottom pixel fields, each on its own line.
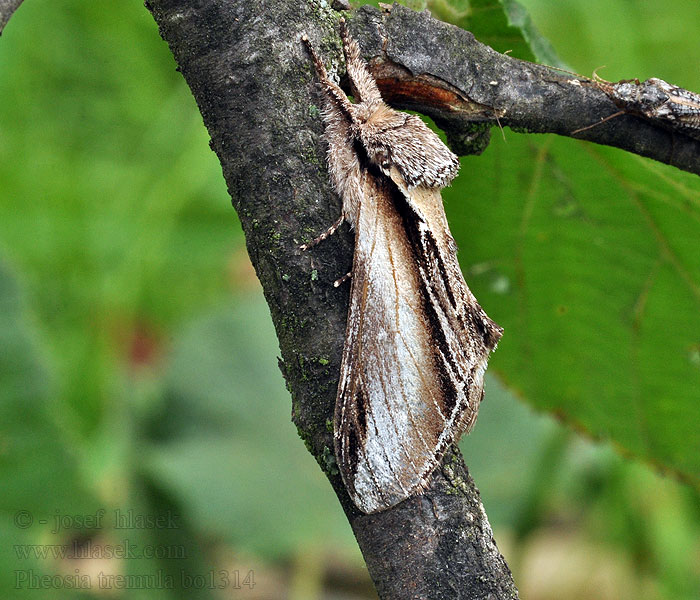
left=144, top=298, right=354, bottom=557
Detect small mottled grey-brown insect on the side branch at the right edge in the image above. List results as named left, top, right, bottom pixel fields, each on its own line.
left=574, top=77, right=700, bottom=139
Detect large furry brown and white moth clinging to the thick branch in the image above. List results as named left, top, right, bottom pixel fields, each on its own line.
left=302, top=21, right=503, bottom=513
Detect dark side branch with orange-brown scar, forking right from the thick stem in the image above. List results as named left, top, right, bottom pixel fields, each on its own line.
left=351, top=5, right=700, bottom=175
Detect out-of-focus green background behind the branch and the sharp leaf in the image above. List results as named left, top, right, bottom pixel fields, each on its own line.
left=0, top=0, right=700, bottom=600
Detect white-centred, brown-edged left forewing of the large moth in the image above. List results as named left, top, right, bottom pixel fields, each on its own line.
left=335, top=174, right=445, bottom=512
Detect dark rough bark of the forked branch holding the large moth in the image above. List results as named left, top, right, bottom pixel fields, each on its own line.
left=139, top=0, right=700, bottom=600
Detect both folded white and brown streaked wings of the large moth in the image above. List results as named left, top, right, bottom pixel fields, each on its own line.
left=335, top=171, right=500, bottom=513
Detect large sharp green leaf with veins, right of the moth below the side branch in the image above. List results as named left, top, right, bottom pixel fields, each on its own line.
left=444, top=134, right=700, bottom=485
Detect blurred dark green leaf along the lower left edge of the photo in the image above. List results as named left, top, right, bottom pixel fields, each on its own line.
left=0, top=259, right=94, bottom=598
